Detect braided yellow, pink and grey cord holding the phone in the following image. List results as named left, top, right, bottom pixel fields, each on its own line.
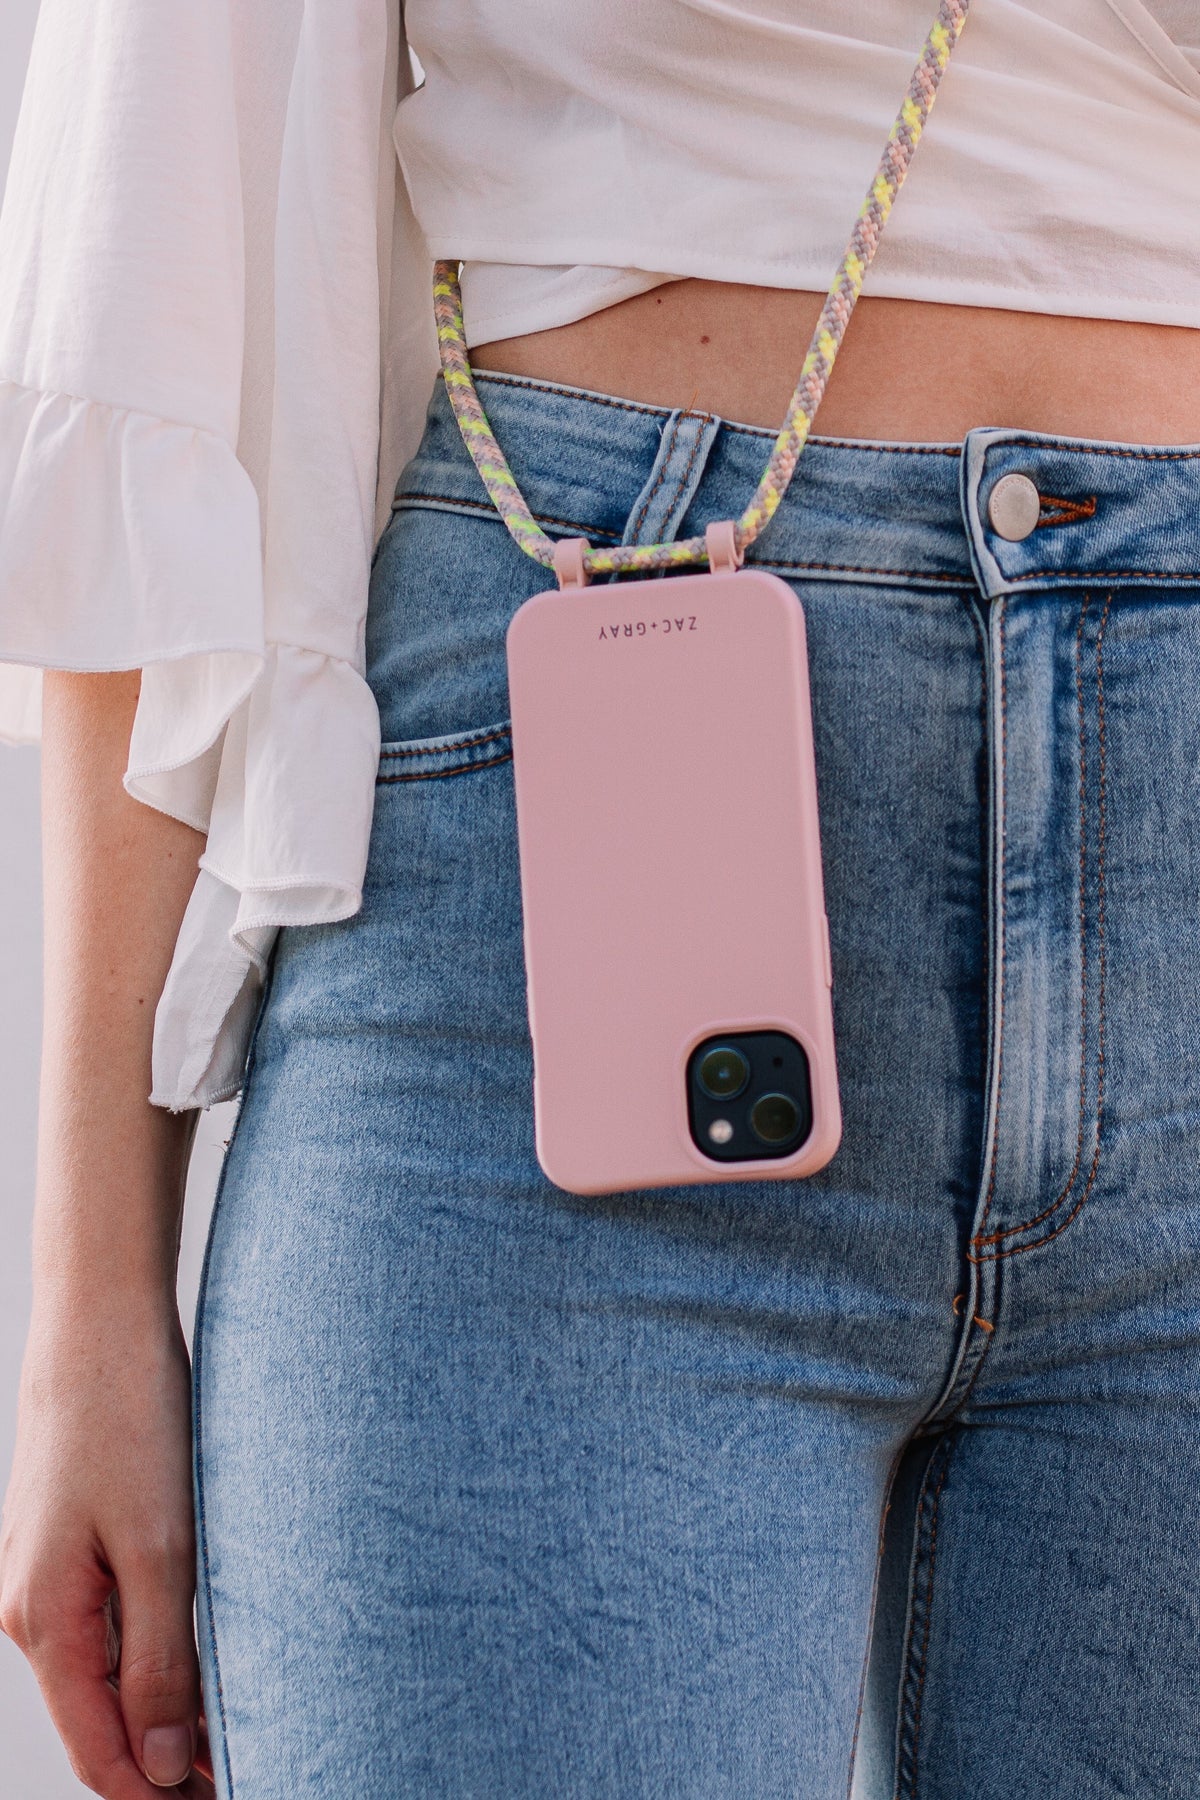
left=434, top=0, right=970, bottom=585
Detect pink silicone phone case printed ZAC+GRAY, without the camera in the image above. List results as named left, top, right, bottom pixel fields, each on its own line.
left=507, top=554, right=842, bottom=1193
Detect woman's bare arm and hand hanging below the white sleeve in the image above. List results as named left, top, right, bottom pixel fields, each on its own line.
left=0, top=673, right=210, bottom=1800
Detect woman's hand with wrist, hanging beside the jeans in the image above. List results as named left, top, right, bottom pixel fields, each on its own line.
left=0, top=1292, right=212, bottom=1800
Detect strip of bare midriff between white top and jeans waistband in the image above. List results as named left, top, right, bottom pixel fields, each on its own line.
left=471, top=281, right=1200, bottom=445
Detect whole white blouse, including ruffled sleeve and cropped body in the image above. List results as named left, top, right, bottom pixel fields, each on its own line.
left=0, top=0, right=1200, bottom=1109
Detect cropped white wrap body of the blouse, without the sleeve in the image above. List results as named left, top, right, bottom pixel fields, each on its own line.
left=396, top=0, right=1200, bottom=344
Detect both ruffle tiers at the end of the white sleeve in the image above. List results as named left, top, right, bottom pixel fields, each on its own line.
left=0, top=380, right=380, bottom=1111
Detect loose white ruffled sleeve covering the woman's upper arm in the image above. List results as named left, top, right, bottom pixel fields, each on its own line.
left=0, top=0, right=437, bottom=1109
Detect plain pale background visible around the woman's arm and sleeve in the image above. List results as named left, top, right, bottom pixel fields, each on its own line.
left=0, top=10, right=232, bottom=1800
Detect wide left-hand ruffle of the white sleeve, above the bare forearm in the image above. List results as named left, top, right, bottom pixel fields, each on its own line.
left=0, top=380, right=263, bottom=748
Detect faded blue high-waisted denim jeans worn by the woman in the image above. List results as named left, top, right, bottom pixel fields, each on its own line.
left=196, top=376, right=1200, bottom=1800
